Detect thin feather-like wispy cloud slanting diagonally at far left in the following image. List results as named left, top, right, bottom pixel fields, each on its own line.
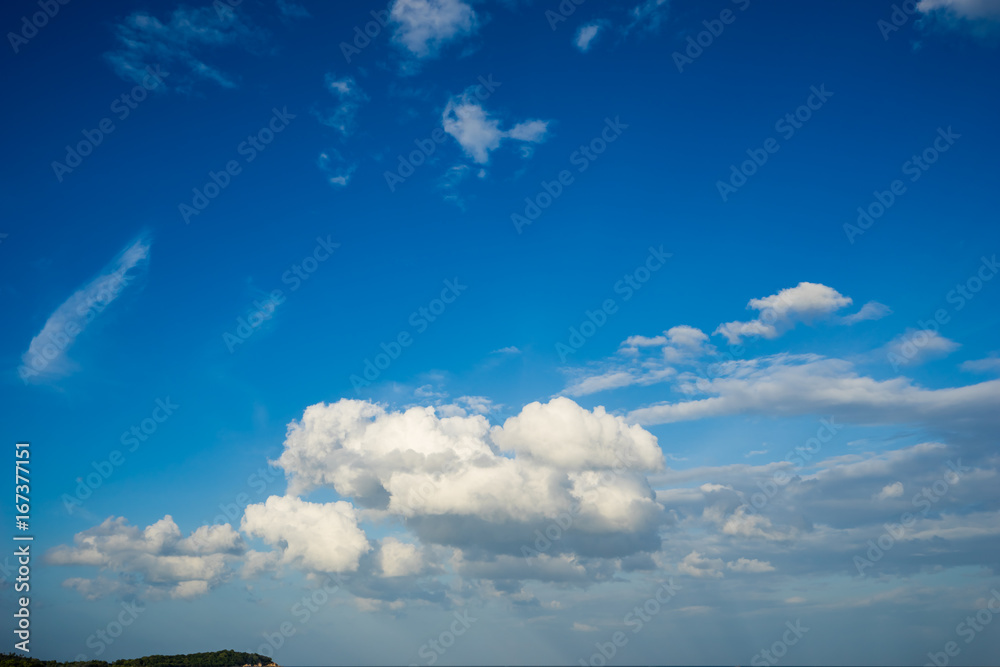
left=18, top=238, right=150, bottom=382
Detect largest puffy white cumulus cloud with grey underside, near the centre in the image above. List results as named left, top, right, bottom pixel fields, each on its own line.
left=277, top=398, right=663, bottom=556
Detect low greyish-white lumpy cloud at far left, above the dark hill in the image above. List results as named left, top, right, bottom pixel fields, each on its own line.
left=46, top=514, right=246, bottom=599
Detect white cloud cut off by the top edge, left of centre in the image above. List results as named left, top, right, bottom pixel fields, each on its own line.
left=389, top=0, right=479, bottom=59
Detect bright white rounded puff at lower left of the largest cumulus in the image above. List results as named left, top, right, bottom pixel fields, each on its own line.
left=240, top=496, right=371, bottom=572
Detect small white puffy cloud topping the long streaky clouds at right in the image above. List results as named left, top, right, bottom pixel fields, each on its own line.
left=715, top=282, right=860, bottom=344
